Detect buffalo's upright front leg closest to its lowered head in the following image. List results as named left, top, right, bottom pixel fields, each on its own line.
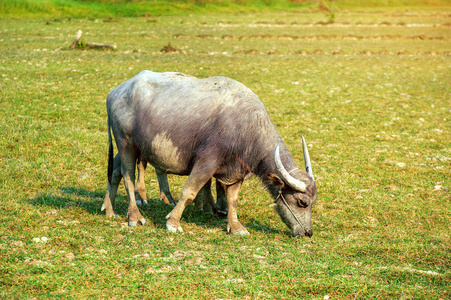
left=223, top=181, right=249, bottom=235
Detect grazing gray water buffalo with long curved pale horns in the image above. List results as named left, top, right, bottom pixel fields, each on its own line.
left=103, top=71, right=316, bottom=236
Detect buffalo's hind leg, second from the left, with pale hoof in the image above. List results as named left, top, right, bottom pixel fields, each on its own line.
left=120, top=151, right=146, bottom=227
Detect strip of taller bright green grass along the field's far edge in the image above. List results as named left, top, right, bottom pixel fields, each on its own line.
left=0, top=0, right=451, bottom=20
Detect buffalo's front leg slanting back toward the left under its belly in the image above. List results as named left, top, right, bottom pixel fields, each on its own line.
left=166, top=158, right=216, bottom=232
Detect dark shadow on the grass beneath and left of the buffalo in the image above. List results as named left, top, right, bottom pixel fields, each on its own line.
left=28, top=186, right=230, bottom=228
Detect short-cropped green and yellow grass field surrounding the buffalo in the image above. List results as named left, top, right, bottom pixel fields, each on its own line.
left=0, top=1, right=451, bottom=299
